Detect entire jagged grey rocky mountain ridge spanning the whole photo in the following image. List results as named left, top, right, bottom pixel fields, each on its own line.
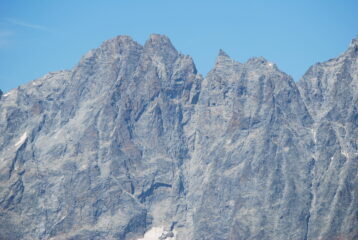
left=0, top=34, right=358, bottom=240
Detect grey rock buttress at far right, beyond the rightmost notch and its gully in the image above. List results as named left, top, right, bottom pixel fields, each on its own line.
left=298, top=35, right=358, bottom=239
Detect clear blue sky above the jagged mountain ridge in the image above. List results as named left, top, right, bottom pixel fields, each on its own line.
left=0, top=0, right=358, bottom=92
